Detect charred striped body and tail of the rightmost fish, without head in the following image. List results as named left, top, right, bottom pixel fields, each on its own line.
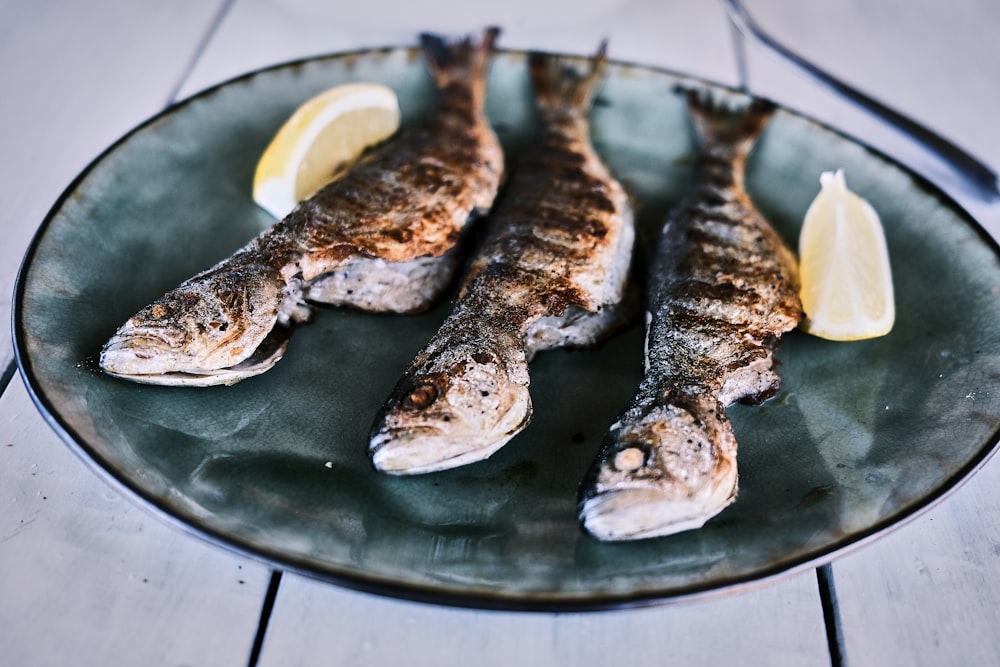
left=649, top=94, right=802, bottom=399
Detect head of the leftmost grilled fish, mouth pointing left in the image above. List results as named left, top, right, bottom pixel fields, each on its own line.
left=100, top=272, right=283, bottom=384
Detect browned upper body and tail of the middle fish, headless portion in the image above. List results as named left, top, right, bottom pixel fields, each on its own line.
left=462, top=44, right=629, bottom=321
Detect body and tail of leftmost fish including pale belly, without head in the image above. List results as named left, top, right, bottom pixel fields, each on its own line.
left=294, top=28, right=504, bottom=313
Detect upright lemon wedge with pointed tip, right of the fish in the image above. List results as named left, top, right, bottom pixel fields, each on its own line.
left=799, top=170, right=896, bottom=341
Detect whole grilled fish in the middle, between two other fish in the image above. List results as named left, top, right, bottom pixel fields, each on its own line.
left=369, top=45, right=634, bottom=474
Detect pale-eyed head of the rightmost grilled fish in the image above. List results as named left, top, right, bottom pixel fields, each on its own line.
left=579, top=396, right=737, bottom=540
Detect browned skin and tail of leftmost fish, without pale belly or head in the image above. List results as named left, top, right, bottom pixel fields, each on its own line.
left=258, top=29, right=504, bottom=281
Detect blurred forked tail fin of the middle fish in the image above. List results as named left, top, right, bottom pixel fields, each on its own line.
left=528, top=40, right=608, bottom=113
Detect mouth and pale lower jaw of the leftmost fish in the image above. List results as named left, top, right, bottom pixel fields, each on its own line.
left=100, top=327, right=291, bottom=387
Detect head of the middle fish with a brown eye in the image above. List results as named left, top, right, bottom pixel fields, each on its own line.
left=369, top=349, right=531, bottom=474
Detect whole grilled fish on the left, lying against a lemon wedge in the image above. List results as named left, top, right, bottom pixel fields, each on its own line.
left=100, top=28, right=504, bottom=386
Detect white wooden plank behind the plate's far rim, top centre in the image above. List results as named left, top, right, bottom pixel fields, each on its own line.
left=174, top=0, right=736, bottom=95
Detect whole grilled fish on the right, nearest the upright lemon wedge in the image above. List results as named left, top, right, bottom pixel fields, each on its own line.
left=579, top=93, right=801, bottom=540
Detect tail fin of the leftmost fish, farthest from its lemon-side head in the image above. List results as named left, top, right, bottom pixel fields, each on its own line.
left=420, top=27, right=500, bottom=100
